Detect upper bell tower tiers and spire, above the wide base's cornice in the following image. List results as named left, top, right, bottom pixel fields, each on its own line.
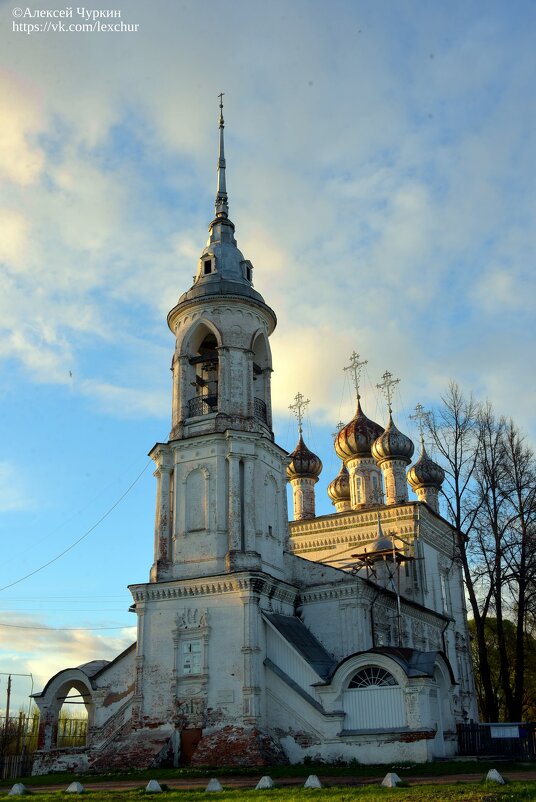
left=151, top=101, right=288, bottom=582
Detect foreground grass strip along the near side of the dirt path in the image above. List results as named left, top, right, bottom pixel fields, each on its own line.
left=0, top=782, right=536, bottom=802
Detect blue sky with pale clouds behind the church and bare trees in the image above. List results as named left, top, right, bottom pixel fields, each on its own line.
left=0, top=0, right=536, bottom=707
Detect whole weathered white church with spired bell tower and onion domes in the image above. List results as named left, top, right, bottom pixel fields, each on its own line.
left=34, top=103, right=477, bottom=773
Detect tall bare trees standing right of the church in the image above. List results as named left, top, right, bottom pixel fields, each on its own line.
left=428, top=382, right=536, bottom=722
